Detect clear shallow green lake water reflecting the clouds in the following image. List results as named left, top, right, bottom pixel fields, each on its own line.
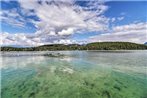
left=0, top=51, right=147, bottom=98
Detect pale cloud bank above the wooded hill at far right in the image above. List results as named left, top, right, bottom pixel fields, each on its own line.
left=89, top=23, right=147, bottom=44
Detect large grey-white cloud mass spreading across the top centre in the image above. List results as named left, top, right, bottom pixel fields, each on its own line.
left=20, top=0, right=108, bottom=35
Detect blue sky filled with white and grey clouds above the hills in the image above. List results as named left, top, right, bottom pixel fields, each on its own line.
left=0, top=0, right=147, bottom=46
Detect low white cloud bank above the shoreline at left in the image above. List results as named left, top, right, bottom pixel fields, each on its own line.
left=0, top=32, right=78, bottom=46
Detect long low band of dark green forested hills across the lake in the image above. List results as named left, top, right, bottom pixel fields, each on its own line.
left=1, top=42, right=147, bottom=51
